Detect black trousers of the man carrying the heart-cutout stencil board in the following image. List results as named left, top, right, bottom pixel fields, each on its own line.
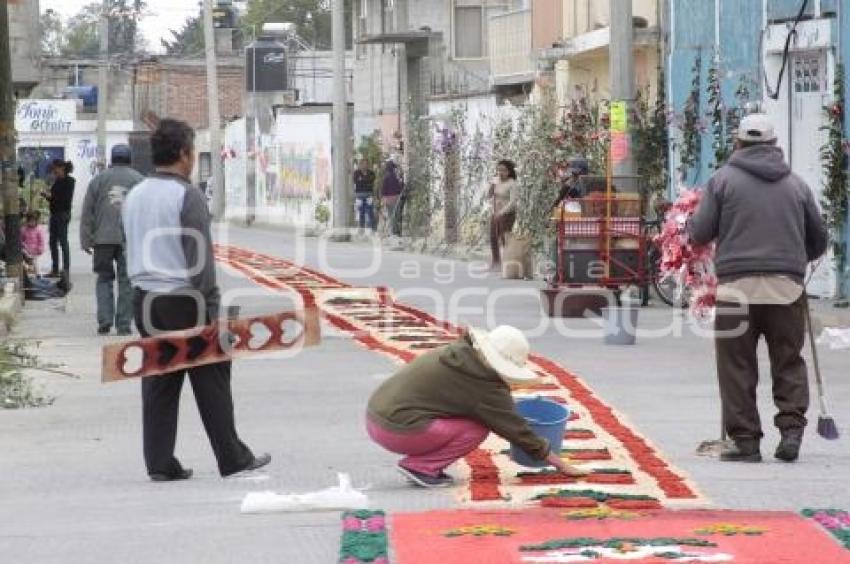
left=133, top=289, right=254, bottom=476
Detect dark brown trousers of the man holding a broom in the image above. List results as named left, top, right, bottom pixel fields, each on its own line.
left=715, top=298, right=809, bottom=439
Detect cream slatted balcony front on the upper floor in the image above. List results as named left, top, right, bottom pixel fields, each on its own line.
left=488, top=9, right=535, bottom=84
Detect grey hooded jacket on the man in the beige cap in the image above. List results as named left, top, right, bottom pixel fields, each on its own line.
left=689, top=145, right=827, bottom=282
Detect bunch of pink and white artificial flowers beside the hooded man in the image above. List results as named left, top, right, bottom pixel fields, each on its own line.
left=656, top=189, right=717, bottom=319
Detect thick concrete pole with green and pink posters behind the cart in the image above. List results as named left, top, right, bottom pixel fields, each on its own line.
left=608, top=0, right=637, bottom=176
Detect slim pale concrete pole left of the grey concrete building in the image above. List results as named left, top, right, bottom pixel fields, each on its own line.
left=331, top=0, right=351, bottom=235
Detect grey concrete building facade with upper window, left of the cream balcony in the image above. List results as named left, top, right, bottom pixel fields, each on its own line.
left=353, top=0, right=528, bottom=144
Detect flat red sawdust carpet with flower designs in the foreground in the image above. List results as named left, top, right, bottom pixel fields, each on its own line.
left=390, top=509, right=850, bottom=564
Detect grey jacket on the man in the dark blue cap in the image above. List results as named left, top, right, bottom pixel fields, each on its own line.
left=80, top=165, right=145, bottom=249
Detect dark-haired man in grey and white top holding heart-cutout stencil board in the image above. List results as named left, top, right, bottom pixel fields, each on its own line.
left=123, top=119, right=271, bottom=482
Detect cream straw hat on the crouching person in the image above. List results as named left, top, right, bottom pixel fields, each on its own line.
left=469, top=325, right=539, bottom=384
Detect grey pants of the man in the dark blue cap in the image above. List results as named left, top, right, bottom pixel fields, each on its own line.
left=93, top=245, right=133, bottom=331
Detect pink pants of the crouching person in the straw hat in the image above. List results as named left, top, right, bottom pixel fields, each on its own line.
left=366, top=417, right=490, bottom=476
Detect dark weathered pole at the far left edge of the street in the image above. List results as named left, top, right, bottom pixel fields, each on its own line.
left=0, top=2, right=21, bottom=279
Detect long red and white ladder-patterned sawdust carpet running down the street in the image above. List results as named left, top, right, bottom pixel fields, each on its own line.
left=216, top=247, right=704, bottom=510
